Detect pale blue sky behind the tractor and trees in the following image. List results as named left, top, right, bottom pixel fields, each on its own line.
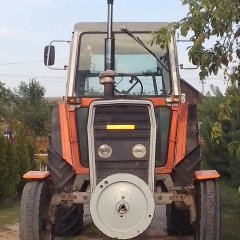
left=0, top=0, right=226, bottom=97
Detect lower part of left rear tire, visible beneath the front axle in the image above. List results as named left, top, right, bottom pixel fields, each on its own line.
left=55, top=203, right=83, bottom=237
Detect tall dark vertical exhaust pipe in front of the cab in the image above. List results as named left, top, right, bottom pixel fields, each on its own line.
left=99, top=0, right=116, bottom=98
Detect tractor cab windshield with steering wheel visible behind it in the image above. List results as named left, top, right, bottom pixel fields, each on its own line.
left=75, top=32, right=171, bottom=96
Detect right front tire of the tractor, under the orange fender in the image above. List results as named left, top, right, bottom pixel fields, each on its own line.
left=195, top=180, right=220, bottom=240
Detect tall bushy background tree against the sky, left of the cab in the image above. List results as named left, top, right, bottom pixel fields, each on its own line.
left=15, top=79, right=49, bottom=135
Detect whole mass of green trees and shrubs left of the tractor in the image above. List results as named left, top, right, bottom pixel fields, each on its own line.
left=0, top=79, right=49, bottom=203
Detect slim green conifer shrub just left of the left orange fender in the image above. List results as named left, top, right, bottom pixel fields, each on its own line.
left=16, top=126, right=31, bottom=193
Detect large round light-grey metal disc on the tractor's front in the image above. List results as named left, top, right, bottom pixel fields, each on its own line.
left=90, top=173, right=155, bottom=239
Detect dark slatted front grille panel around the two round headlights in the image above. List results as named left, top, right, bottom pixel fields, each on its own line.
left=93, top=104, right=151, bottom=183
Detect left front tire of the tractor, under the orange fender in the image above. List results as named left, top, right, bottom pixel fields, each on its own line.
left=19, top=181, right=54, bottom=240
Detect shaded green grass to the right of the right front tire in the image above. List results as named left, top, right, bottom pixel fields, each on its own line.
left=220, top=179, right=240, bottom=240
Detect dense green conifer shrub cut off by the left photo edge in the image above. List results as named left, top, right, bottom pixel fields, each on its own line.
left=0, top=133, right=19, bottom=202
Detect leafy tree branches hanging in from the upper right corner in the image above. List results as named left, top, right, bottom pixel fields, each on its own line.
left=152, top=0, right=240, bottom=154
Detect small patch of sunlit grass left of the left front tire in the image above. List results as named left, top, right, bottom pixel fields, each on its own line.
left=0, top=200, right=20, bottom=231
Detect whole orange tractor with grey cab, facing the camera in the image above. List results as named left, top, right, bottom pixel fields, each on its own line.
left=20, top=0, right=220, bottom=240
